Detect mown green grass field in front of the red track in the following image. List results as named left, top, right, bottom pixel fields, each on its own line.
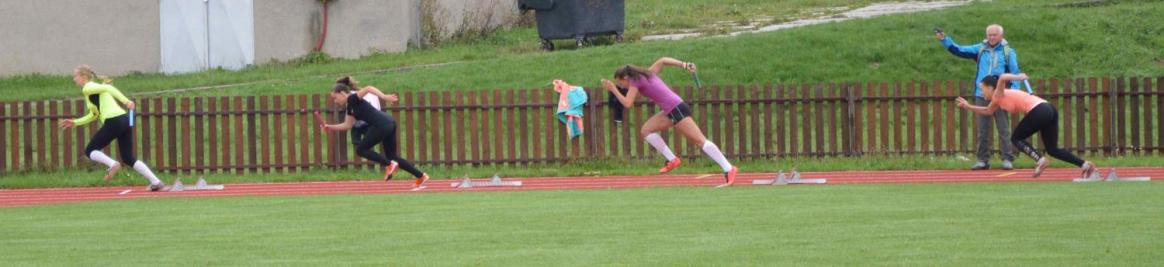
left=0, top=183, right=1164, bottom=266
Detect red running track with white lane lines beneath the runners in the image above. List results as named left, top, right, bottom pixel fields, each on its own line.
left=0, top=168, right=1164, bottom=208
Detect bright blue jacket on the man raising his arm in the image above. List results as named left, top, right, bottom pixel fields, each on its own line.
left=942, top=36, right=1034, bottom=97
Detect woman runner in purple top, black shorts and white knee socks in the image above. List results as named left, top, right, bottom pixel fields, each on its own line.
left=602, top=57, right=739, bottom=187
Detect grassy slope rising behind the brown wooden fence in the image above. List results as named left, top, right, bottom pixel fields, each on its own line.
left=0, top=1, right=1164, bottom=100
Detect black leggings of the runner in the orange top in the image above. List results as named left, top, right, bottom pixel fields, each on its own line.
left=1010, top=103, right=1084, bottom=167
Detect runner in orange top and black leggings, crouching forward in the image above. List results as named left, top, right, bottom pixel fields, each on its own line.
left=956, top=73, right=1096, bottom=177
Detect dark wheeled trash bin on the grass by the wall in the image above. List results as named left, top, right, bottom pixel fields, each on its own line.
left=518, top=0, right=626, bottom=50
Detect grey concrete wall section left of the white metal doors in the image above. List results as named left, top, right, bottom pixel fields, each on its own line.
left=0, top=0, right=162, bottom=76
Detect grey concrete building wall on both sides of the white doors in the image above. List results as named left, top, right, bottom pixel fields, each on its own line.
left=0, top=0, right=517, bottom=76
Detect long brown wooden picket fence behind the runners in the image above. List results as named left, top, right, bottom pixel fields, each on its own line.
left=0, top=77, right=1164, bottom=173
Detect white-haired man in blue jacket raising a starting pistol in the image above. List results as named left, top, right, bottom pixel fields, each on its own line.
left=936, top=24, right=1034, bottom=170
